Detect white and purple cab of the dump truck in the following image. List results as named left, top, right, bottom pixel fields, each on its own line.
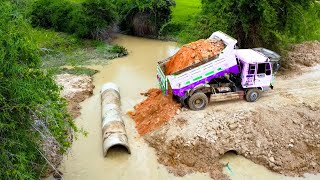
left=235, top=49, right=273, bottom=91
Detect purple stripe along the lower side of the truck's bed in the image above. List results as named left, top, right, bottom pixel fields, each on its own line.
left=172, top=65, right=239, bottom=97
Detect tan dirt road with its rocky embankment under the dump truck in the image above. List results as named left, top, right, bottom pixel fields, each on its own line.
left=145, top=66, right=320, bottom=179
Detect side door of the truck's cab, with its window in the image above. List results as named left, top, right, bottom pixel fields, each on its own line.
left=254, top=62, right=272, bottom=87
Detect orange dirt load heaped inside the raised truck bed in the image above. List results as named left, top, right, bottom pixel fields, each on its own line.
left=165, top=39, right=225, bottom=75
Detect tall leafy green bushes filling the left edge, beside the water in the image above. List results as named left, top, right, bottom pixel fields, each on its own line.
left=0, top=1, right=77, bottom=179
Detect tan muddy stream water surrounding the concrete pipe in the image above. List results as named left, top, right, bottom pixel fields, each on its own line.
left=61, top=35, right=316, bottom=180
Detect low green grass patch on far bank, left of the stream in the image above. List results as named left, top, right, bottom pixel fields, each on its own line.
left=30, top=28, right=128, bottom=72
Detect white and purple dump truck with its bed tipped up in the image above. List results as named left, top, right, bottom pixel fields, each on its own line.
left=157, top=31, right=280, bottom=110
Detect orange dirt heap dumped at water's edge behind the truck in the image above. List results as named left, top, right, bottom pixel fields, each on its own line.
left=128, top=89, right=180, bottom=135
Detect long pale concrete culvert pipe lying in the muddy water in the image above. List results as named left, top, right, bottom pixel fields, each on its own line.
left=101, top=83, right=131, bottom=157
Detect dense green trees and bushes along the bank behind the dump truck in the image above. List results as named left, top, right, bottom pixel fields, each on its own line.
left=168, top=0, right=320, bottom=51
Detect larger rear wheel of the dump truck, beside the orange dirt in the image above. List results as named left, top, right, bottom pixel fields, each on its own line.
left=188, top=92, right=208, bottom=111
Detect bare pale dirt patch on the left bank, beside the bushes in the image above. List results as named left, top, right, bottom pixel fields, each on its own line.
left=55, top=74, right=94, bottom=118
